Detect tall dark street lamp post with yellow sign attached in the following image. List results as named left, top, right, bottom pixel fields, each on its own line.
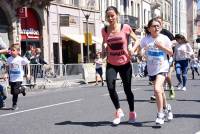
left=81, top=9, right=91, bottom=63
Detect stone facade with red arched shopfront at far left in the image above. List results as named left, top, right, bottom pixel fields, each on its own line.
left=0, top=0, right=48, bottom=57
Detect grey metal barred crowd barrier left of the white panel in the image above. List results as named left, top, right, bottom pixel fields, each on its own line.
left=23, top=64, right=86, bottom=88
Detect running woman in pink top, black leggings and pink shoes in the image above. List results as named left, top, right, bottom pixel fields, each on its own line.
left=102, top=6, right=139, bottom=125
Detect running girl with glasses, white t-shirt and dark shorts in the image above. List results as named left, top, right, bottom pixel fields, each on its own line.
left=132, top=19, right=173, bottom=124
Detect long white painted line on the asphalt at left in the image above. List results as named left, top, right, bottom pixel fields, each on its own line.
left=0, top=99, right=83, bottom=118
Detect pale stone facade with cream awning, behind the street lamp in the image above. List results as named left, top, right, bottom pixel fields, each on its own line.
left=48, top=0, right=102, bottom=64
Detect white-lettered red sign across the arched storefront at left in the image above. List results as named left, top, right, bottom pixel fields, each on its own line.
left=21, top=28, right=40, bottom=40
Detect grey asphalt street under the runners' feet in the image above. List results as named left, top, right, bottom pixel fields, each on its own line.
left=0, top=73, right=200, bottom=134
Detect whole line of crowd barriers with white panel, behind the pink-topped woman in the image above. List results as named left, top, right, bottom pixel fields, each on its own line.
left=19, top=63, right=144, bottom=88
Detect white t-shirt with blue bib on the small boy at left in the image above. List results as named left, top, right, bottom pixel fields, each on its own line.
left=7, top=56, right=29, bottom=82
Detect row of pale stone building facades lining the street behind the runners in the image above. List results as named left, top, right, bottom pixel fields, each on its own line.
left=0, top=0, right=199, bottom=64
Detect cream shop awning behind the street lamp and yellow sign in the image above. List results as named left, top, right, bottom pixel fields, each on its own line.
left=61, top=32, right=102, bottom=44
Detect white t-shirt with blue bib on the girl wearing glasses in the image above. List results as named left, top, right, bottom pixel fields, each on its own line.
left=140, top=34, right=172, bottom=76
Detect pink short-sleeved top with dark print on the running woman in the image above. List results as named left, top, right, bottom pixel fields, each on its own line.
left=102, top=24, right=132, bottom=66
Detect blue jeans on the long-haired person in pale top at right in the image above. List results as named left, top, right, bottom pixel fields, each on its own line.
left=175, top=59, right=189, bottom=87
